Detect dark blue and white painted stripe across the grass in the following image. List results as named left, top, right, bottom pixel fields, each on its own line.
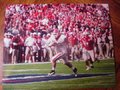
left=2, top=73, right=113, bottom=84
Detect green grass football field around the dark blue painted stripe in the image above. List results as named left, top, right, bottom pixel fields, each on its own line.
left=3, top=59, right=116, bottom=90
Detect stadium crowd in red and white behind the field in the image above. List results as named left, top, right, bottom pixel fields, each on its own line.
left=3, top=4, right=114, bottom=64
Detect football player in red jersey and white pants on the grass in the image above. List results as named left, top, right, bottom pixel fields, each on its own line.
left=82, top=32, right=95, bottom=70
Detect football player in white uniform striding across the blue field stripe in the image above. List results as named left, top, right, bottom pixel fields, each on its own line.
left=48, top=29, right=77, bottom=76
